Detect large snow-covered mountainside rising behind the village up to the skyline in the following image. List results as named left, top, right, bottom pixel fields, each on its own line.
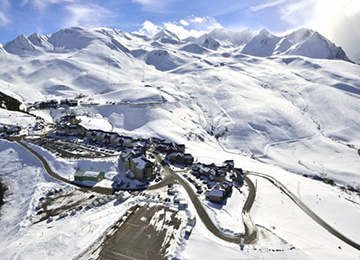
left=0, top=27, right=360, bottom=187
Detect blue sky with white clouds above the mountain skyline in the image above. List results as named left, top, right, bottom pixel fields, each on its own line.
left=0, top=0, right=360, bottom=58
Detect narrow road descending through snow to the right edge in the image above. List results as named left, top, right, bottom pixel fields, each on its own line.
left=245, top=172, right=360, bottom=250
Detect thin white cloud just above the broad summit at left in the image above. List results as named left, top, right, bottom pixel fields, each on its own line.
left=63, top=4, right=114, bottom=27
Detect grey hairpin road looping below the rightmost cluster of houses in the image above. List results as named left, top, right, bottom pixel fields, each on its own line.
left=164, top=166, right=257, bottom=244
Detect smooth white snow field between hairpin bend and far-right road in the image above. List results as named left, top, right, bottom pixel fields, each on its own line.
left=250, top=176, right=359, bottom=259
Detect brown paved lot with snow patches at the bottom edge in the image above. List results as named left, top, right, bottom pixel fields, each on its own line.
left=98, top=206, right=181, bottom=260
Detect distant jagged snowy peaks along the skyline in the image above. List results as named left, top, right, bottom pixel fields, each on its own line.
left=0, top=28, right=351, bottom=61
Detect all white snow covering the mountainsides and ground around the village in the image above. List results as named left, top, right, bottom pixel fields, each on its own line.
left=0, top=27, right=360, bottom=259
